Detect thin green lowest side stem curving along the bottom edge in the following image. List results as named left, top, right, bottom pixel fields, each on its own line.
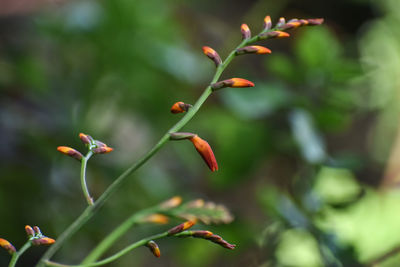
left=45, top=232, right=168, bottom=267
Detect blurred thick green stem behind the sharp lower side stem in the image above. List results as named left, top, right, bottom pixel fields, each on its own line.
left=82, top=207, right=156, bottom=264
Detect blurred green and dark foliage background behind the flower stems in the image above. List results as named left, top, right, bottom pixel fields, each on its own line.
left=0, top=0, right=400, bottom=267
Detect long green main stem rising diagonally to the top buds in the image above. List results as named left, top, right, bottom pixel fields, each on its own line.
left=37, top=30, right=259, bottom=267
